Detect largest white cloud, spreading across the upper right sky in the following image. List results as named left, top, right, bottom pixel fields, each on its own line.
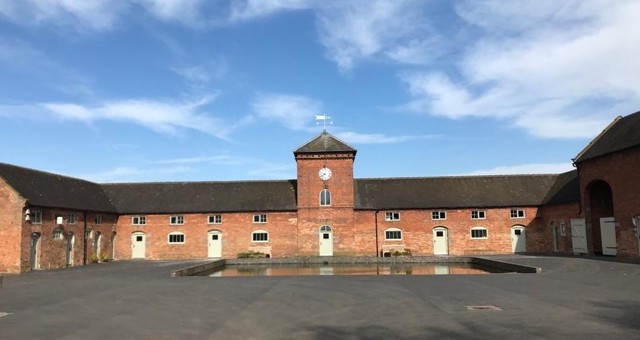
left=400, top=1, right=640, bottom=138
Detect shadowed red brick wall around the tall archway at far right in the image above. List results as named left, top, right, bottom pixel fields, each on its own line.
left=578, top=147, right=640, bottom=257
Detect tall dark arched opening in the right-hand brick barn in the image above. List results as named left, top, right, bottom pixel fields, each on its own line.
left=588, top=180, right=617, bottom=255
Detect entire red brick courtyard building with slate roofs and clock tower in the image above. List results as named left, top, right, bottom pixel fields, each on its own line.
left=0, top=113, right=640, bottom=272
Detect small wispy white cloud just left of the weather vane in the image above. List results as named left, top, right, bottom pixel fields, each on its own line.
left=251, top=93, right=323, bottom=130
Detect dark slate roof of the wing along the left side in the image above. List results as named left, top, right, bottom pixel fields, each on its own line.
left=0, top=163, right=115, bottom=212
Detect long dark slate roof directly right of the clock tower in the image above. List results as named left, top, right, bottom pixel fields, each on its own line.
left=354, top=175, right=558, bottom=210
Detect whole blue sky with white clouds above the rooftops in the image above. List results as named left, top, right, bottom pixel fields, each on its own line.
left=0, top=0, right=640, bottom=182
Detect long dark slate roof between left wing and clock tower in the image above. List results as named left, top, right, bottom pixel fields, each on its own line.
left=102, top=180, right=297, bottom=214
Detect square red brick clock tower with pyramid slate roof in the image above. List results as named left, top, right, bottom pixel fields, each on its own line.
left=293, top=130, right=356, bottom=256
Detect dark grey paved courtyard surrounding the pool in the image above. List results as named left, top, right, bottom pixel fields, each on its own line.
left=0, top=256, right=640, bottom=339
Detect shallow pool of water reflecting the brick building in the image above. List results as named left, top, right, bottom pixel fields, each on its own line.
left=201, top=263, right=504, bottom=277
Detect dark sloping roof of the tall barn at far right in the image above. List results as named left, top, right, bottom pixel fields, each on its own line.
left=574, top=112, right=640, bottom=163
